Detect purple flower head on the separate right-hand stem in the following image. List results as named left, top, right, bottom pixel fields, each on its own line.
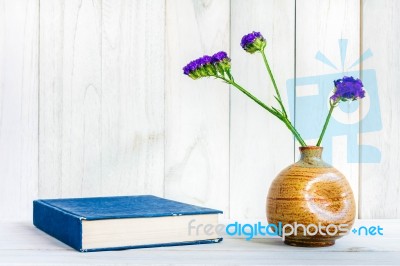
left=331, top=76, right=365, bottom=102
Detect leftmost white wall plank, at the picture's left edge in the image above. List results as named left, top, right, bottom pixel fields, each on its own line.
left=0, top=0, right=39, bottom=220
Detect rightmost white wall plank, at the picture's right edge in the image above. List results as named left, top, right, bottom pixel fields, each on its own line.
left=360, top=0, right=400, bottom=218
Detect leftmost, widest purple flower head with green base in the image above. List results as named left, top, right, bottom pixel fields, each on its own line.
left=183, top=51, right=231, bottom=79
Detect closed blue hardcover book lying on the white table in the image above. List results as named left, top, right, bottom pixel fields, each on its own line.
left=33, top=195, right=222, bottom=252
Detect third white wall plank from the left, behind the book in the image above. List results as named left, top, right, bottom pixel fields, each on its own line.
left=101, top=0, right=165, bottom=196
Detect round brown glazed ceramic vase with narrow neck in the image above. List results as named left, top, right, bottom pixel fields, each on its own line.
left=267, top=146, right=355, bottom=247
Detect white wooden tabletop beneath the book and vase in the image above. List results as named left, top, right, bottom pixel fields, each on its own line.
left=0, top=220, right=400, bottom=265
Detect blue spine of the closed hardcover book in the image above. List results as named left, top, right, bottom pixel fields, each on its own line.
left=33, top=200, right=82, bottom=251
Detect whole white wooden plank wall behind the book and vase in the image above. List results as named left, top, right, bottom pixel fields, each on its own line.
left=0, top=0, right=400, bottom=220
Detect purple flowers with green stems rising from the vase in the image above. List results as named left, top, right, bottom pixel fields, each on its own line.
left=183, top=31, right=365, bottom=147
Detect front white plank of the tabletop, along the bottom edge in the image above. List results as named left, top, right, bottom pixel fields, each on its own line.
left=0, top=249, right=400, bottom=266
